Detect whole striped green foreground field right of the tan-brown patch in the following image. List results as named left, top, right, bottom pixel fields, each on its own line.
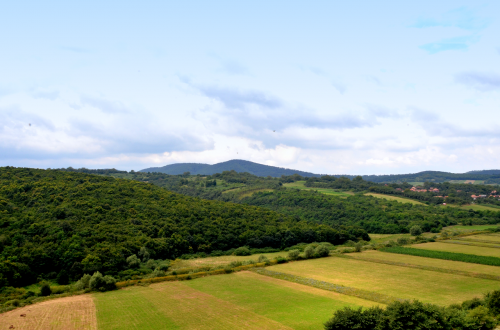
left=94, top=272, right=377, bottom=330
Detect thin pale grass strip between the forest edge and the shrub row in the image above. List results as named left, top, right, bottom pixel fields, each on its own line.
left=170, top=251, right=288, bottom=270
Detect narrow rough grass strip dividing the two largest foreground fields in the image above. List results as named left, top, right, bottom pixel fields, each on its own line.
left=251, top=268, right=406, bottom=305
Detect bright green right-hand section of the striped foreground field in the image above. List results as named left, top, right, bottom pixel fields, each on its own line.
left=186, top=272, right=374, bottom=329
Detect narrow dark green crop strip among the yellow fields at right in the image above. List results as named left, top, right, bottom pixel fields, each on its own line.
left=381, top=246, right=500, bottom=266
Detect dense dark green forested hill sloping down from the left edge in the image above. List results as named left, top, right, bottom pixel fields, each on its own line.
left=0, top=167, right=367, bottom=290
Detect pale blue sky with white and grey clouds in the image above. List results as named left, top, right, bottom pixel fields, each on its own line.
left=0, top=0, right=500, bottom=174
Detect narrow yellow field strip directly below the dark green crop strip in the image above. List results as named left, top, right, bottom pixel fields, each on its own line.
left=349, top=250, right=500, bottom=278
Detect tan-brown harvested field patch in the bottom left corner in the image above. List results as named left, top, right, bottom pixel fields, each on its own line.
left=0, top=295, right=97, bottom=330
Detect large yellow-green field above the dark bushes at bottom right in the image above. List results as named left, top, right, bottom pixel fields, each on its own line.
left=266, top=257, right=498, bottom=305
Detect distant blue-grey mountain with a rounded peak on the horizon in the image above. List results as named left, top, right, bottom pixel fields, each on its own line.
left=140, top=159, right=321, bottom=177
